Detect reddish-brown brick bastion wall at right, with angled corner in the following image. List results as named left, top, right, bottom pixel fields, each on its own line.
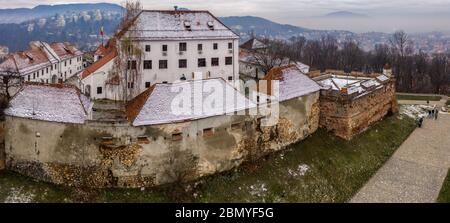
left=320, top=80, right=398, bottom=140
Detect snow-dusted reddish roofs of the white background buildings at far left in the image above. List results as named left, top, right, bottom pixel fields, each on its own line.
left=0, top=41, right=83, bottom=74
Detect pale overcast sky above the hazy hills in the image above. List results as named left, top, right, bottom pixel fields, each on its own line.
left=0, top=0, right=450, bottom=32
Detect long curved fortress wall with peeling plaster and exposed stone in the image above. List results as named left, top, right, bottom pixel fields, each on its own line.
left=5, top=92, right=319, bottom=187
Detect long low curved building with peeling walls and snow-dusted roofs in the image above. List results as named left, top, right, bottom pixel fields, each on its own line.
left=0, top=68, right=320, bottom=187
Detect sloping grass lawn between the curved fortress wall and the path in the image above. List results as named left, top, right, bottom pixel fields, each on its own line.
left=0, top=116, right=415, bottom=202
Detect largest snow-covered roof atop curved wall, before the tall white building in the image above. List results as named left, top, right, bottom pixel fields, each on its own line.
left=127, top=78, right=256, bottom=126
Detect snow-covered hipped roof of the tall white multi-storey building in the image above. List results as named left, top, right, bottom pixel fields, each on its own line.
left=125, top=10, right=239, bottom=40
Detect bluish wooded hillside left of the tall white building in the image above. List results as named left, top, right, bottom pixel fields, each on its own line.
left=0, top=10, right=121, bottom=52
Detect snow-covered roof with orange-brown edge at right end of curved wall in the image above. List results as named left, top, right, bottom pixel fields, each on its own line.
left=264, top=64, right=321, bottom=101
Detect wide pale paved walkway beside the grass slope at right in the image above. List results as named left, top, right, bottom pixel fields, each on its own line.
left=350, top=113, right=450, bottom=203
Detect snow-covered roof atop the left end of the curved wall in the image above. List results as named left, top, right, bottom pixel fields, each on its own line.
left=5, top=83, right=93, bottom=124
